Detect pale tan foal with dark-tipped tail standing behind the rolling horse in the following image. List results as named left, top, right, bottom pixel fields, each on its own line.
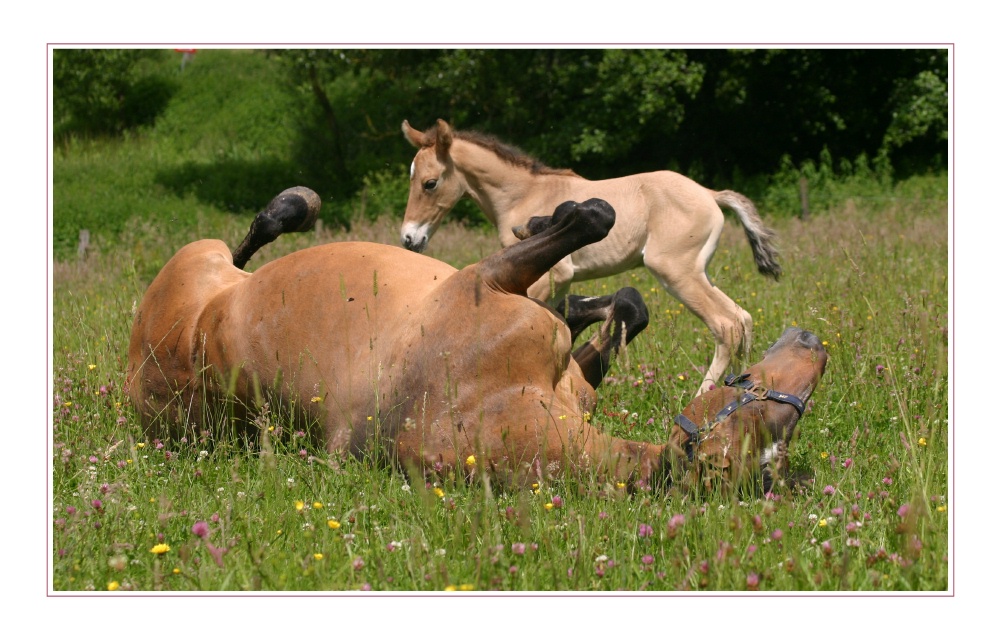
left=400, top=120, right=781, bottom=394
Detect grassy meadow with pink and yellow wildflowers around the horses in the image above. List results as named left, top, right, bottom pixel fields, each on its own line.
left=50, top=184, right=952, bottom=593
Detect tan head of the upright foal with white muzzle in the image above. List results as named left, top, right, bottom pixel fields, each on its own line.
left=399, top=120, right=468, bottom=252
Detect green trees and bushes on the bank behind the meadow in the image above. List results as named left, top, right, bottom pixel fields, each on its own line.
left=53, top=49, right=948, bottom=260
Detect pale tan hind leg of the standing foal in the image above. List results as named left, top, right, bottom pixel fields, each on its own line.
left=646, top=256, right=753, bottom=394
